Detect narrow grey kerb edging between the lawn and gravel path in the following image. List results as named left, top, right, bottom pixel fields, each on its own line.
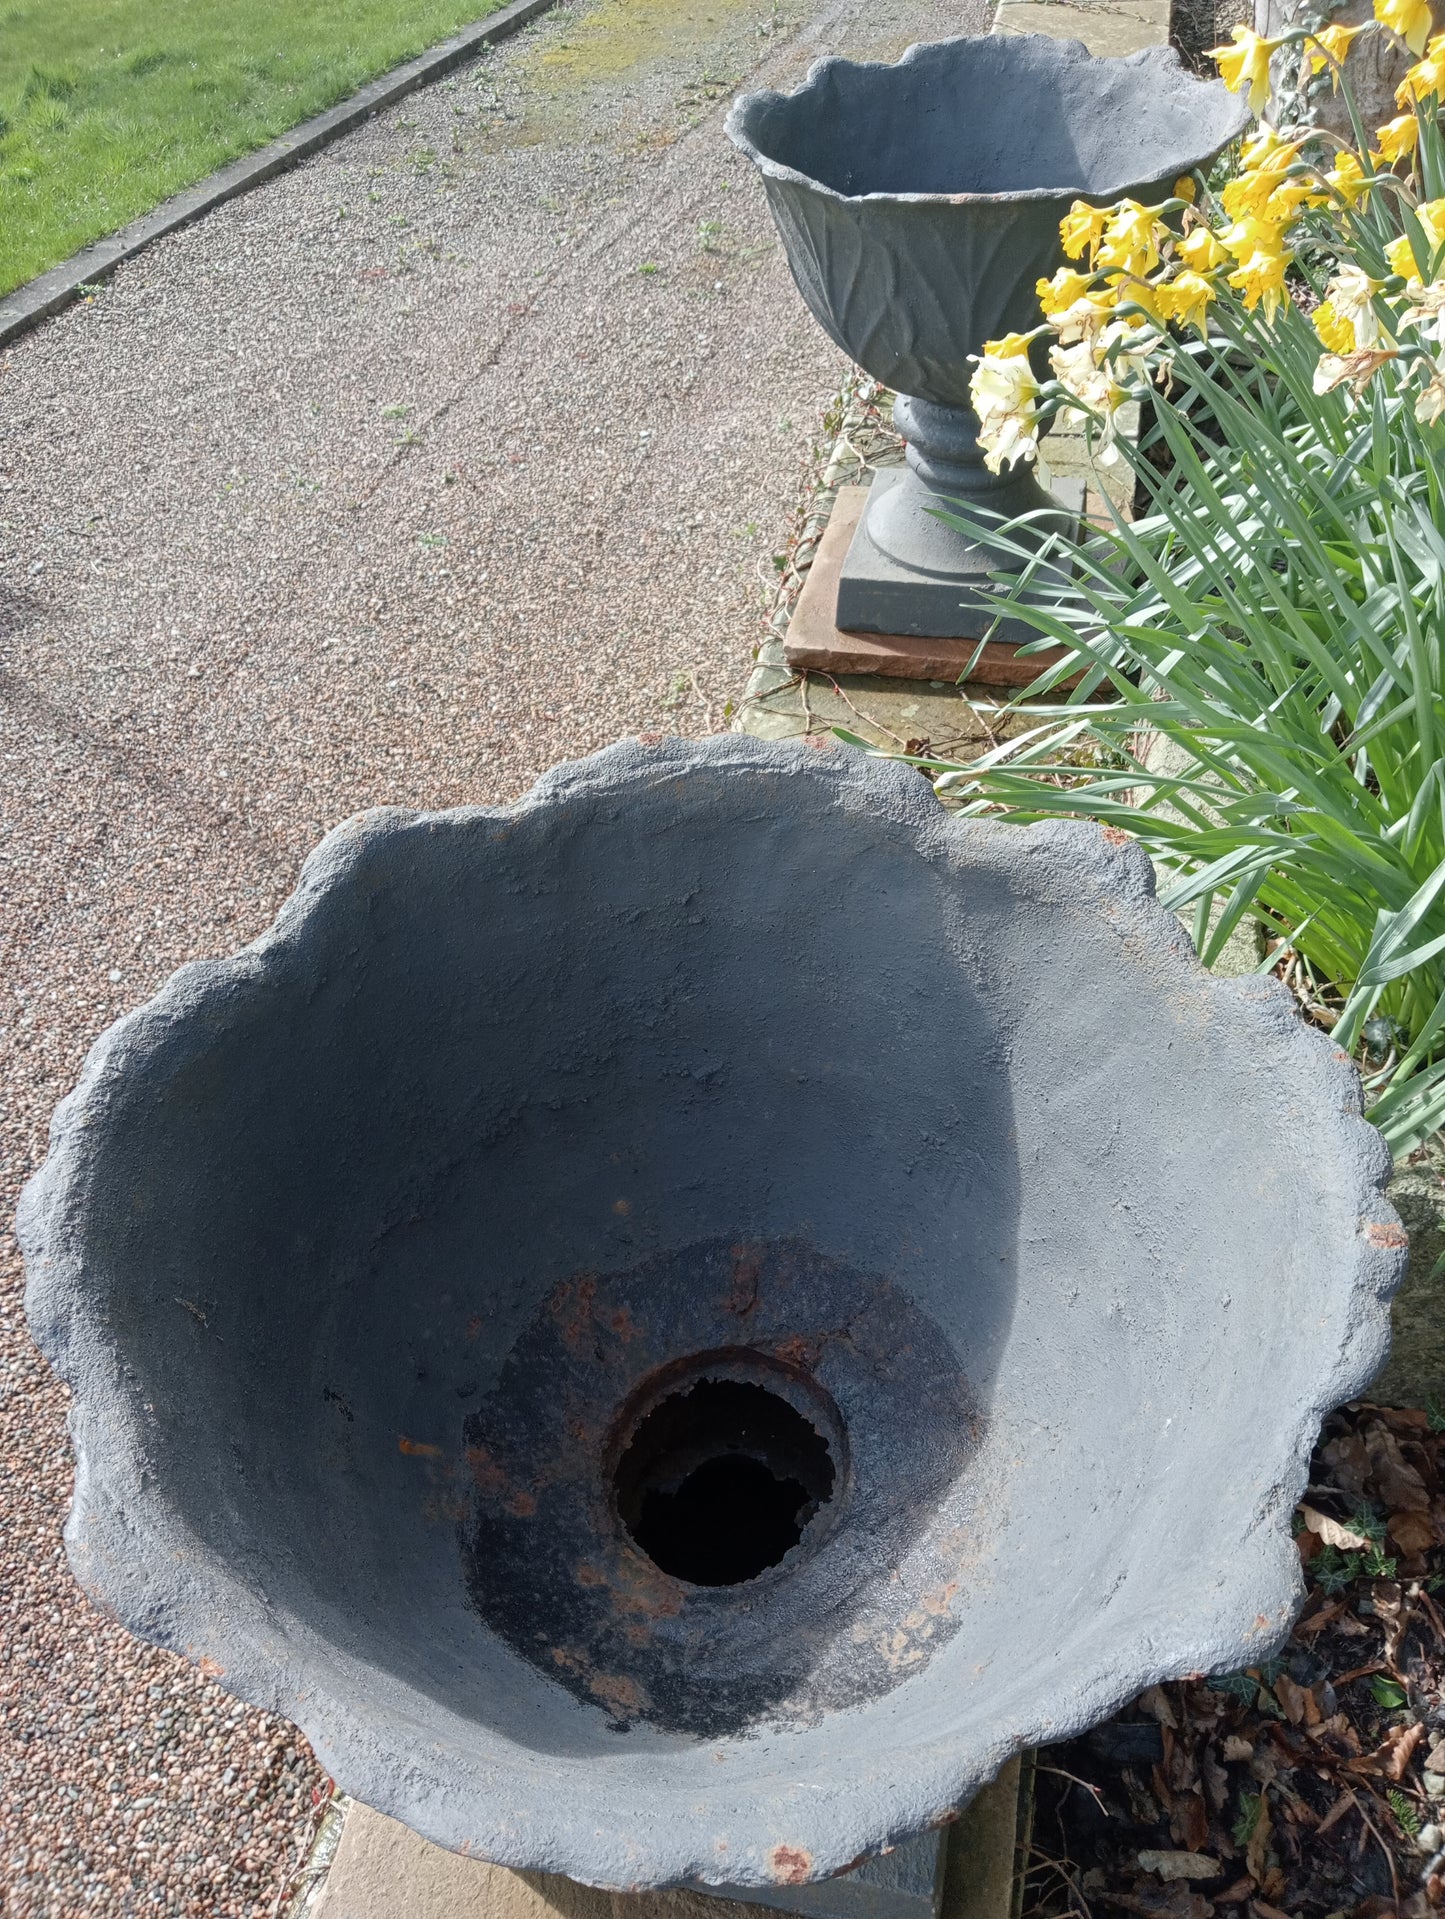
left=0, top=0, right=557, bottom=347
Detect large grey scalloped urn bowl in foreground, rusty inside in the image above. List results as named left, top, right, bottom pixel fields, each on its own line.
left=19, top=737, right=1403, bottom=1886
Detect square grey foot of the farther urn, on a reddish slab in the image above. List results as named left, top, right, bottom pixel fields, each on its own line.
left=835, top=466, right=1084, bottom=640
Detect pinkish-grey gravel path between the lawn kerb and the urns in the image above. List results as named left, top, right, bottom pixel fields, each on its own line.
left=0, top=0, right=983, bottom=1919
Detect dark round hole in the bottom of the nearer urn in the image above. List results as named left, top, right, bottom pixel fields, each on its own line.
left=612, top=1378, right=837, bottom=1585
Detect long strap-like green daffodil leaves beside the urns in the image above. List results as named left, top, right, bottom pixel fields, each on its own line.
left=875, top=196, right=1445, bottom=1153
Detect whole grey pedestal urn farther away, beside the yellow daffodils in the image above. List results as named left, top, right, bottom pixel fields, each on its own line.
left=727, top=35, right=1249, bottom=635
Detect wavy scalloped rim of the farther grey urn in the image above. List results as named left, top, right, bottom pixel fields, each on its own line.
left=723, top=33, right=1253, bottom=207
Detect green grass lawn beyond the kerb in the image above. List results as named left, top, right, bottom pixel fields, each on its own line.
left=0, top=0, right=501, bottom=294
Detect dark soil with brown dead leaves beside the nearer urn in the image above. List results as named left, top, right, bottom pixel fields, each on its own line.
left=1023, top=1403, right=1445, bottom=1919
